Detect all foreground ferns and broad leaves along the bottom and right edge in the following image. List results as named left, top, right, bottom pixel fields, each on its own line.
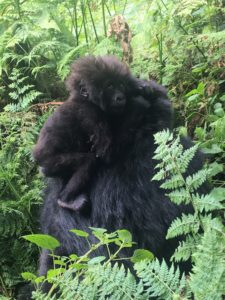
left=20, top=131, right=225, bottom=300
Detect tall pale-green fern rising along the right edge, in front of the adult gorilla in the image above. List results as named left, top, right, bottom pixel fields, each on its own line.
left=153, top=131, right=225, bottom=299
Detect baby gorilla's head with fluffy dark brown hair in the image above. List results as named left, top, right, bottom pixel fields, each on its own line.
left=66, top=56, right=131, bottom=114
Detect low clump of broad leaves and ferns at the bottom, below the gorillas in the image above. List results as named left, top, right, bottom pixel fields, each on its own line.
left=23, top=228, right=188, bottom=300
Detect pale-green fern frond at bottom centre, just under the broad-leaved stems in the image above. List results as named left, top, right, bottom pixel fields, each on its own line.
left=52, top=264, right=145, bottom=300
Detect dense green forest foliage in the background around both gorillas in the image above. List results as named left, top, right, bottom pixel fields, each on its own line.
left=0, top=0, right=225, bottom=299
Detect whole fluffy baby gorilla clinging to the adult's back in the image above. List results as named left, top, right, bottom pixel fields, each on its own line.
left=33, top=56, right=149, bottom=211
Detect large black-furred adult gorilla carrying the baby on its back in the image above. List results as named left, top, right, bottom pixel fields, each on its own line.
left=40, top=55, right=202, bottom=284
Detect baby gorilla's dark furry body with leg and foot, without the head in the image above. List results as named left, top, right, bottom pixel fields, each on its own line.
left=33, top=99, right=111, bottom=210
